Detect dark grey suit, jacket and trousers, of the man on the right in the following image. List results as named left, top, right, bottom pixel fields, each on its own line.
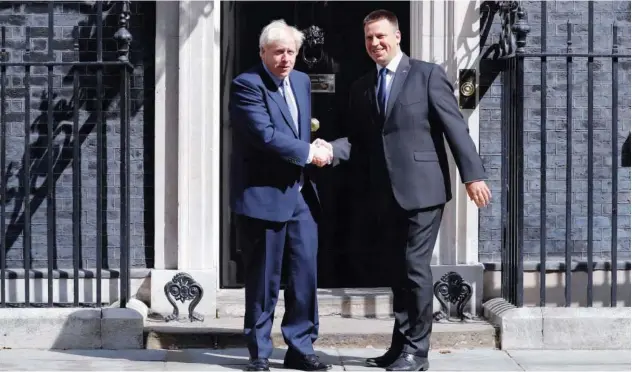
left=332, top=55, right=485, bottom=357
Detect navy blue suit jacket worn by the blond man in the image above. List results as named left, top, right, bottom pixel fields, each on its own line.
left=229, top=64, right=315, bottom=222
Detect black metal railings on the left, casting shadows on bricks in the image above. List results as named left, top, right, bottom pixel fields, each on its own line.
left=0, top=1, right=133, bottom=307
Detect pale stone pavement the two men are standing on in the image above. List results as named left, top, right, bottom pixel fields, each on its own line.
left=0, top=348, right=630, bottom=371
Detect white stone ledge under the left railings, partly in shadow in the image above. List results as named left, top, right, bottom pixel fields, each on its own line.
left=0, top=300, right=147, bottom=349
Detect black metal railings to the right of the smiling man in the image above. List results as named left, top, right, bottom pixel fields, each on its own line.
left=496, top=1, right=630, bottom=306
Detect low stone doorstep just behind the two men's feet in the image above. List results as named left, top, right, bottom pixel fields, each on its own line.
left=144, top=316, right=497, bottom=349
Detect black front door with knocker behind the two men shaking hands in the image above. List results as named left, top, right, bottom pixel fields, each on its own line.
left=221, top=1, right=410, bottom=288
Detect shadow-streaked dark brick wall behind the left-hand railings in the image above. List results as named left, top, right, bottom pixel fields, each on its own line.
left=0, top=1, right=154, bottom=268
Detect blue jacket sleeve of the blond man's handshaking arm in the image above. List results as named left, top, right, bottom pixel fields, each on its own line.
left=229, top=79, right=310, bottom=167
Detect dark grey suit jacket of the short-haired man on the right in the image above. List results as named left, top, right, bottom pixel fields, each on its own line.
left=334, top=55, right=485, bottom=210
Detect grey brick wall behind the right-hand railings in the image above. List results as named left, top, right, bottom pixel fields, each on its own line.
left=479, top=1, right=631, bottom=262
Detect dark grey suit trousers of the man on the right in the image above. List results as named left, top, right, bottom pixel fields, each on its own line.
left=377, top=190, right=444, bottom=357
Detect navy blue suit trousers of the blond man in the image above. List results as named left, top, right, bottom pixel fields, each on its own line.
left=236, top=193, right=319, bottom=358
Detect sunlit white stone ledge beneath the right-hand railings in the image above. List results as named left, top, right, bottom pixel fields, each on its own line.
left=483, top=298, right=631, bottom=350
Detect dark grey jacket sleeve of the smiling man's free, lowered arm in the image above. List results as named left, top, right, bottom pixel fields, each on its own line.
left=428, top=65, right=486, bottom=183
